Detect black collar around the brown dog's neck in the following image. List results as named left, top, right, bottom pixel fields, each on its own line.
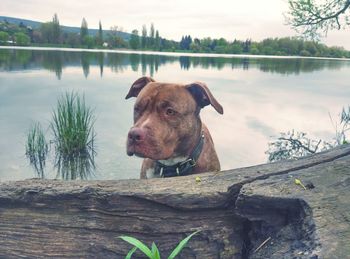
left=154, top=133, right=204, bottom=177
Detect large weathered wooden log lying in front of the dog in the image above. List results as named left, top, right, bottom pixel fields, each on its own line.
left=0, top=145, right=350, bottom=259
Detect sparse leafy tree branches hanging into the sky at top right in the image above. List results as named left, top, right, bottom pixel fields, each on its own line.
left=286, top=0, right=350, bottom=38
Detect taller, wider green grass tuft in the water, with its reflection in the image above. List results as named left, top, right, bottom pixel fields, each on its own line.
left=50, top=92, right=95, bottom=180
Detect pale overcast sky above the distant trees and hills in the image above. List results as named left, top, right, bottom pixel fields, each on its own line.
left=0, top=0, right=350, bottom=50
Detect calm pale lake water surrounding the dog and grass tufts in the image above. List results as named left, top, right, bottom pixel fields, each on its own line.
left=0, top=49, right=350, bottom=181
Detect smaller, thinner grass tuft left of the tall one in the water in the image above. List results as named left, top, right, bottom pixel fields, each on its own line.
left=26, top=123, right=49, bottom=178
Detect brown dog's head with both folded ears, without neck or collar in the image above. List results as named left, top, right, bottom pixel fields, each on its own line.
left=126, top=77, right=223, bottom=160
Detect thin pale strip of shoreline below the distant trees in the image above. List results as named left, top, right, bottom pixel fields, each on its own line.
left=0, top=46, right=350, bottom=61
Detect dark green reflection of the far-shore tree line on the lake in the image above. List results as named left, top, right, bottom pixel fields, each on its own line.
left=0, top=49, right=350, bottom=79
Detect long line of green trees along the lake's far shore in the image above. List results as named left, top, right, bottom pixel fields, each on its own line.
left=0, top=14, right=350, bottom=58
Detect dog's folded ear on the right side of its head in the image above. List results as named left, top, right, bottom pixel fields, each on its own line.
left=186, top=82, right=224, bottom=114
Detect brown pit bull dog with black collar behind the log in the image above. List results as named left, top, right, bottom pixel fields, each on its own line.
left=125, top=77, right=224, bottom=178
